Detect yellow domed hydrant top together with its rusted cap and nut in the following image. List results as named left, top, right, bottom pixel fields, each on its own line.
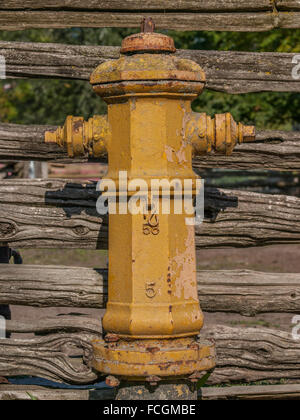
left=90, top=18, right=205, bottom=97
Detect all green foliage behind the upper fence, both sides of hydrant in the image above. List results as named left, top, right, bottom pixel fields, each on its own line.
left=0, top=28, right=300, bottom=129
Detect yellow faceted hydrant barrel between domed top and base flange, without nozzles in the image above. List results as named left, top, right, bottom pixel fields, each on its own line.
left=103, top=96, right=203, bottom=339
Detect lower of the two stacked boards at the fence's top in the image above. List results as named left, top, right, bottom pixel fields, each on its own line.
left=0, top=10, right=300, bottom=32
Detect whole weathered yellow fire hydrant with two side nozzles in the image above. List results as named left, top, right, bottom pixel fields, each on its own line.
left=45, top=19, right=255, bottom=398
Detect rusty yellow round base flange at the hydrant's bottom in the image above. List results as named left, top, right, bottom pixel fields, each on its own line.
left=92, top=338, right=215, bottom=381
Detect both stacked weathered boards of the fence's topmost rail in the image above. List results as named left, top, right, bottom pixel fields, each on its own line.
left=0, top=0, right=300, bottom=31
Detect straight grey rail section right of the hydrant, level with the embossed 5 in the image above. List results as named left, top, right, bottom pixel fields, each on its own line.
left=197, top=270, right=300, bottom=316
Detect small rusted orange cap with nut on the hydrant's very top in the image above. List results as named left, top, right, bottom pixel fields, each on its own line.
left=121, top=18, right=176, bottom=54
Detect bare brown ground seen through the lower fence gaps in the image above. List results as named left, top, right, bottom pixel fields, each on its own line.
left=12, top=245, right=300, bottom=338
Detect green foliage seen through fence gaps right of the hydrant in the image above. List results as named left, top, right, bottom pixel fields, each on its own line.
left=169, top=29, right=300, bottom=130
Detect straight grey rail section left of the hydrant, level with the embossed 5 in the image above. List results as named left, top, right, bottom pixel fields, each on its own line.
left=0, top=264, right=107, bottom=308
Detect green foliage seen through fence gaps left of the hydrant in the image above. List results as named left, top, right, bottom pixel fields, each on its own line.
left=0, top=28, right=133, bottom=124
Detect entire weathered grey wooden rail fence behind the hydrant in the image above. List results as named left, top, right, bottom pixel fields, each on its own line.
left=0, top=0, right=300, bottom=399
